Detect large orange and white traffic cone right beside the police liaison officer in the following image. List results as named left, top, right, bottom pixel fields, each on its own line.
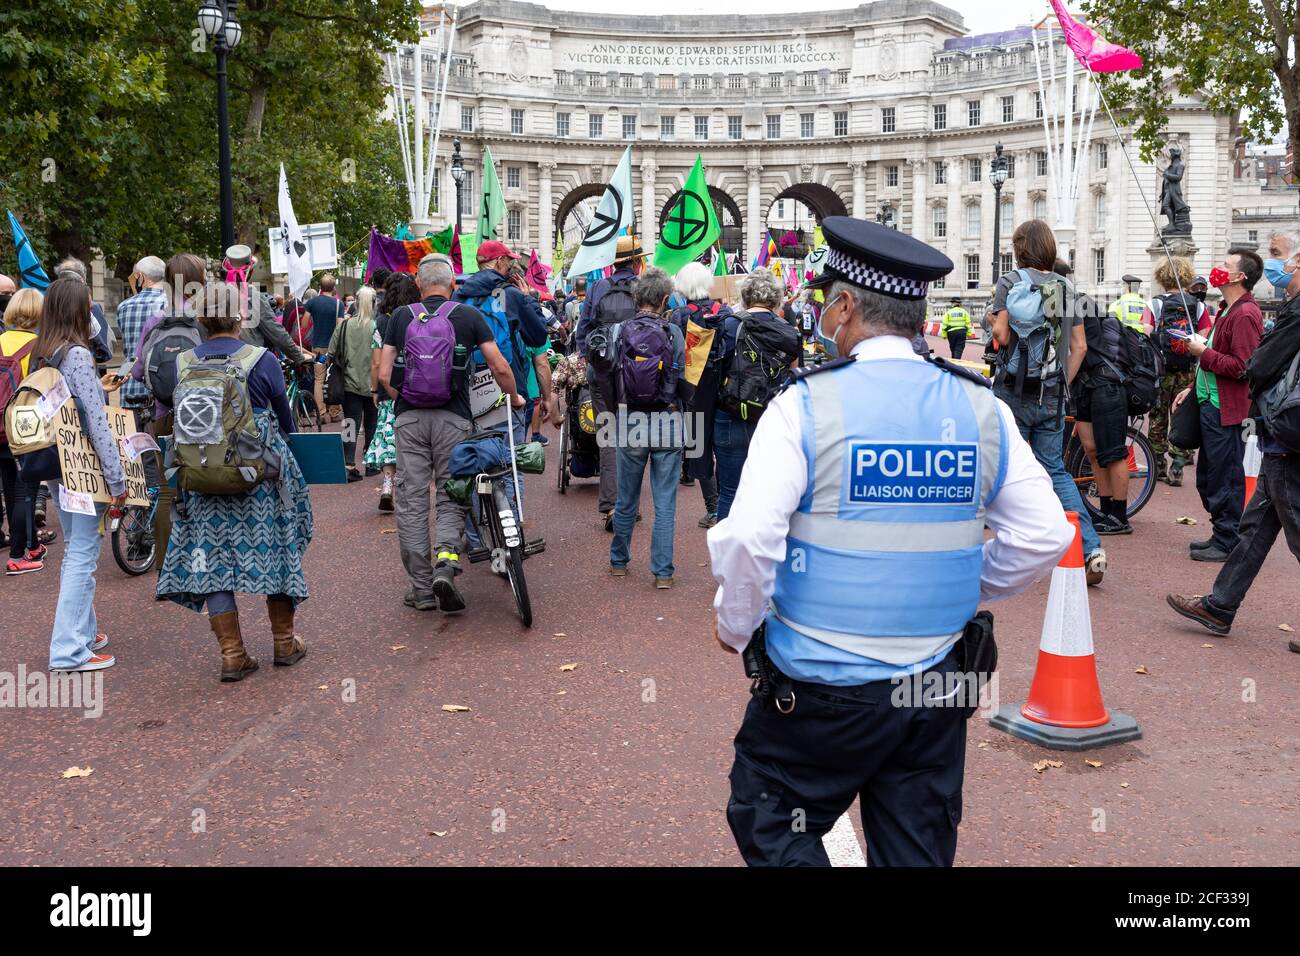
left=989, top=511, right=1141, bottom=750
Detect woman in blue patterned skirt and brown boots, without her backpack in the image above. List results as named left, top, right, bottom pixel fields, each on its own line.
left=157, top=282, right=312, bottom=682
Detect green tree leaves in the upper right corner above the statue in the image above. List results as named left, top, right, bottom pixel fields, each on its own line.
left=1083, top=0, right=1300, bottom=161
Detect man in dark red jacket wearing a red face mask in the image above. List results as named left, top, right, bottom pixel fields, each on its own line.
left=1174, top=251, right=1264, bottom=562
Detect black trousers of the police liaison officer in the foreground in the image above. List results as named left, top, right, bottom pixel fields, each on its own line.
left=727, top=653, right=966, bottom=866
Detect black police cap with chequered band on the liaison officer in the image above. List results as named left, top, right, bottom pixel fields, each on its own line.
left=809, top=216, right=953, bottom=299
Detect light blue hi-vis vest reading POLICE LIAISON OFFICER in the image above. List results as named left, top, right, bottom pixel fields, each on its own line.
left=767, top=359, right=1006, bottom=684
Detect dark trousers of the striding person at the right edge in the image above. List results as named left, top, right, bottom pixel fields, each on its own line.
left=1197, top=454, right=1300, bottom=620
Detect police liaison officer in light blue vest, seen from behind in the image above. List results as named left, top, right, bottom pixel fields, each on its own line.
left=709, top=216, right=1073, bottom=866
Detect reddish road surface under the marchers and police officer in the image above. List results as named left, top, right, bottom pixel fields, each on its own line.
left=0, top=345, right=1300, bottom=865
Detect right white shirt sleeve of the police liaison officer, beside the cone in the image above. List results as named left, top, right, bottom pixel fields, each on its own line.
left=980, top=399, right=1074, bottom=601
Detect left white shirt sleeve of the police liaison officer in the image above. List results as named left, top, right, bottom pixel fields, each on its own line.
left=709, top=386, right=807, bottom=650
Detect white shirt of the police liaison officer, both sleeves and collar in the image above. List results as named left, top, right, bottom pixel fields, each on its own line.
left=709, top=336, right=1074, bottom=650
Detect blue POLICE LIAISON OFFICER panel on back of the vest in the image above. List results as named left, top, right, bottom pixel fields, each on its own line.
left=849, top=441, right=980, bottom=505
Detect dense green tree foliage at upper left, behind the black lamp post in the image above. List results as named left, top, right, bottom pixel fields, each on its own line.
left=0, top=0, right=419, bottom=276
